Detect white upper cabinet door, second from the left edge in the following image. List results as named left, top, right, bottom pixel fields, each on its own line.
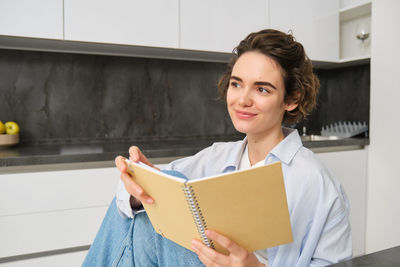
left=64, top=0, right=179, bottom=48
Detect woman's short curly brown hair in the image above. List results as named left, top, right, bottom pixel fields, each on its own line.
left=218, top=29, right=319, bottom=124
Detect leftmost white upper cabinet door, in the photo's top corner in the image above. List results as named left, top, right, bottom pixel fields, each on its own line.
left=0, top=0, right=63, bottom=39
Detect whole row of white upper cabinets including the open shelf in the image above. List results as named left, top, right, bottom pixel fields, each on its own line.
left=0, top=0, right=371, bottom=64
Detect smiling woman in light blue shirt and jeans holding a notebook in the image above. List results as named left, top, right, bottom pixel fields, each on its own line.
left=83, top=30, right=352, bottom=266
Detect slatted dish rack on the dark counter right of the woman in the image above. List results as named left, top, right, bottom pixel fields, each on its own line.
left=321, top=121, right=368, bottom=138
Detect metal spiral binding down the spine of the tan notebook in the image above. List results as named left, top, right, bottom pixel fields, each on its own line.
left=182, top=185, right=215, bottom=248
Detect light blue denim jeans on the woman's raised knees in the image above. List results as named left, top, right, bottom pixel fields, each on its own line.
left=82, top=199, right=204, bottom=267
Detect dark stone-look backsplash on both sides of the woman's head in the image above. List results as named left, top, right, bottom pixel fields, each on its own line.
left=0, top=50, right=370, bottom=143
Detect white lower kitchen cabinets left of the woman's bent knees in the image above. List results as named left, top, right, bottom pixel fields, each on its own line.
left=0, top=168, right=119, bottom=266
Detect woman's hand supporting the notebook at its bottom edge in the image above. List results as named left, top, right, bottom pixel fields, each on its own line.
left=192, top=230, right=265, bottom=267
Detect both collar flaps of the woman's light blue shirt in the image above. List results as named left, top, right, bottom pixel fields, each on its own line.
left=221, top=127, right=303, bottom=173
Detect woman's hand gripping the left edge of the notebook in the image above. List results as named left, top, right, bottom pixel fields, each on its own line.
left=115, top=146, right=158, bottom=208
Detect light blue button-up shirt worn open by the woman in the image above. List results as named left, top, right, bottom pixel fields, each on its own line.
left=117, top=128, right=352, bottom=267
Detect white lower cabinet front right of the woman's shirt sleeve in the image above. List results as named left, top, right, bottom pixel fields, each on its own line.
left=317, top=149, right=367, bottom=256
